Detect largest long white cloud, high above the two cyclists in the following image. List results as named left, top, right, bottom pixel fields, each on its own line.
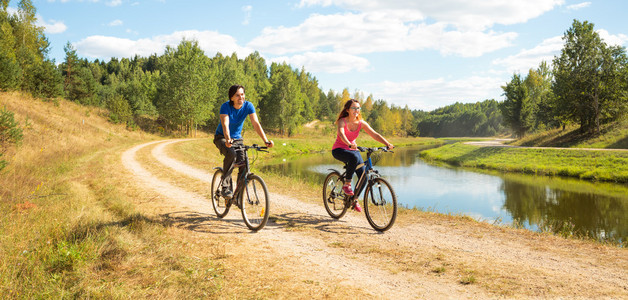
left=248, top=12, right=517, bottom=57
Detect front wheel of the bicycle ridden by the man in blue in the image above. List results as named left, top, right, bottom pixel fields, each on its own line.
left=241, top=175, right=270, bottom=231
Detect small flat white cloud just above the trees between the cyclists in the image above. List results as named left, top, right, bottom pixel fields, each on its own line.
left=270, top=52, right=369, bottom=73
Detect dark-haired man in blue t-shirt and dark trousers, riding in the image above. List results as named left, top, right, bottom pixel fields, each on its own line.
left=214, top=84, right=274, bottom=198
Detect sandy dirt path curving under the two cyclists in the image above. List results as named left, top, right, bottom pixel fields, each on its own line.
left=122, top=140, right=628, bottom=299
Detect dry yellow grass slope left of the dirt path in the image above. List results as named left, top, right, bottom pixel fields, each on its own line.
left=0, top=93, right=223, bottom=299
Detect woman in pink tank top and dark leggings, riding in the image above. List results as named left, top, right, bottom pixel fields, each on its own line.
left=331, top=99, right=394, bottom=212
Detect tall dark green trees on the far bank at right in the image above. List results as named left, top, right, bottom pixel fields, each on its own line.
left=500, top=20, right=628, bottom=137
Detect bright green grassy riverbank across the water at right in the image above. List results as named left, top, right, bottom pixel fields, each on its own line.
left=421, top=143, right=628, bottom=183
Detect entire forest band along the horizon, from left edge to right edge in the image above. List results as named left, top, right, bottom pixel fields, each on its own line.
left=0, top=0, right=628, bottom=142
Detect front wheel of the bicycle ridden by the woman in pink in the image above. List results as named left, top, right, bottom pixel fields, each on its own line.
left=364, top=177, right=397, bottom=231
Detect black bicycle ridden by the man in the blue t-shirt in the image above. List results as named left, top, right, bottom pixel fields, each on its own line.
left=211, top=144, right=270, bottom=231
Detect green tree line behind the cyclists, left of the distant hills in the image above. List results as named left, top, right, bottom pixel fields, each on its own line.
left=0, top=0, right=416, bottom=136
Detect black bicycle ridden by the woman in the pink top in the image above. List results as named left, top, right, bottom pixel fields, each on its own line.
left=323, top=147, right=397, bottom=231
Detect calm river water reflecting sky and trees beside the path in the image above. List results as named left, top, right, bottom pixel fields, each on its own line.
left=263, top=147, right=628, bottom=243
